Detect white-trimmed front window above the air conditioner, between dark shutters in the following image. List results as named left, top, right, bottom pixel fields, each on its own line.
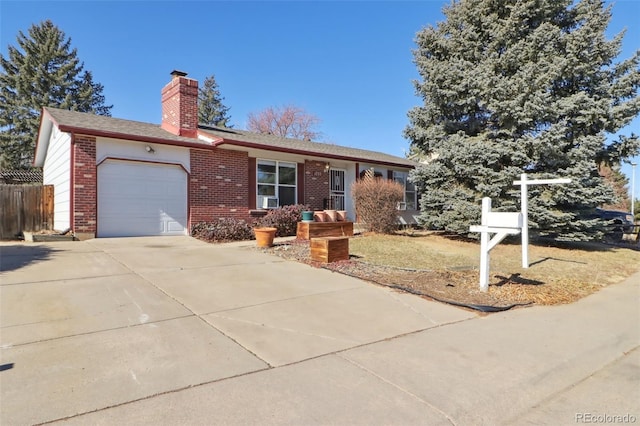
left=256, top=160, right=298, bottom=207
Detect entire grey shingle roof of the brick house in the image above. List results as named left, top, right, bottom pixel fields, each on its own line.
left=44, top=107, right=418, bottom=167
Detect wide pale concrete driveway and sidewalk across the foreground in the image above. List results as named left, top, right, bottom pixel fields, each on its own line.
left=0, top=237, right=640, bottom=426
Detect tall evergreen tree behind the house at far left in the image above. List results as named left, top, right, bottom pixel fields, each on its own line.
left=0, top=20, right=111, bottom=168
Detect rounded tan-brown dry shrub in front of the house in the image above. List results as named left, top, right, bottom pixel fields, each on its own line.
left=351, top=171, right=404, bottom=234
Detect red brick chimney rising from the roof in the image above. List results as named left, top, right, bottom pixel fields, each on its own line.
left=160, top=70, right=198, bottom=138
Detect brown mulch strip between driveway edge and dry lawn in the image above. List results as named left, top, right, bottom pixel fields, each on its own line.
left=254, top=240, right=601, bottom=312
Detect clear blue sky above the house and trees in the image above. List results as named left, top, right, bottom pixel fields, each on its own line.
left=0, top=0, right=640, bottom=198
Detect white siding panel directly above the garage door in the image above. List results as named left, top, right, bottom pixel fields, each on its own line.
left=96, top=138, right=191, bottom=171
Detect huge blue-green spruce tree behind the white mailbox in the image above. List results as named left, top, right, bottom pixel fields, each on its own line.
left=405, top=0, right=640, bottom=240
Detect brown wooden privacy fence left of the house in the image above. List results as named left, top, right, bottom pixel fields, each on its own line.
left=0, top=185, right=53, bottom=239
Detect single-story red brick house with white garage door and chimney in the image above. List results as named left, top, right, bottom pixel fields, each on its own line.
left=34, top=71, right=416, bottom=239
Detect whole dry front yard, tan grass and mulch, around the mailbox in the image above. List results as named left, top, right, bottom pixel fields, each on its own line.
left=258, top=232, right=640, bottom=308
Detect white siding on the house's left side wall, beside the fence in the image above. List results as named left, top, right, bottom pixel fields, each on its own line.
left=42, top=126, right=71, bottom=231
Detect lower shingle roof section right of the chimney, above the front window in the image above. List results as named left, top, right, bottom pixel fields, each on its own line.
left=199, top=125, right=418, bottom=167
